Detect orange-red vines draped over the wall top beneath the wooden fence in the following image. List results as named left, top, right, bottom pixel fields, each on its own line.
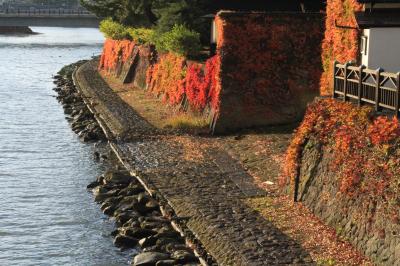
left=283, top=99, right=400, bottom=196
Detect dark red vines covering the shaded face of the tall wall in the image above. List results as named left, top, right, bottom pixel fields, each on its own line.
left=216, top=13, right=323, bottom=114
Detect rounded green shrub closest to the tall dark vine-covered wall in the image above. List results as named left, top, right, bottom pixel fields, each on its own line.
left=155, top=25, right=201, bottom=57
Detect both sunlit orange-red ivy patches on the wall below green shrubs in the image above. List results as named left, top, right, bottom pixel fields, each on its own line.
left=99, top=39, right=220, bottom=113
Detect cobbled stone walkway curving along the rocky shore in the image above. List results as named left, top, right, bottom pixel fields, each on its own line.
left=75, top=62, right=313, bottom=266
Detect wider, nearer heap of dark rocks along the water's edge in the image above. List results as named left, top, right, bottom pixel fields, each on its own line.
left=88, top=170, right=199, bottom=266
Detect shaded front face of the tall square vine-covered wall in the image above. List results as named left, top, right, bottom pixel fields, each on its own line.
left=216, top=12, right=323, bottom=131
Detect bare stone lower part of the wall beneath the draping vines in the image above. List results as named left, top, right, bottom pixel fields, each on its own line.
left=299, top=139, right=400, bottom=265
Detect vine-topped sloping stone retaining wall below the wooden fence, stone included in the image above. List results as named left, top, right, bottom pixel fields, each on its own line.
left=285, top=99, right=400, bottom=265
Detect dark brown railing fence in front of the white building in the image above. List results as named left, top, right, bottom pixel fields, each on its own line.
left=333, top=62, right=400, bottom=116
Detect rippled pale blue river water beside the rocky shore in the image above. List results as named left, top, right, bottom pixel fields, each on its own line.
left=0, top=28, right=130, bottom=265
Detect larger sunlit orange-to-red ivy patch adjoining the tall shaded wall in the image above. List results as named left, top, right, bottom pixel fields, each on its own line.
left=147, top=53, right=219, bottom=112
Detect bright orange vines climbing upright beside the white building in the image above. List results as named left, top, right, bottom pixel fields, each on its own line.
left=321, top=0, right=362, bottom=95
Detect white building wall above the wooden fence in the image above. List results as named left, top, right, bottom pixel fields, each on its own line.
left=362, top=28, right=400, bottom=72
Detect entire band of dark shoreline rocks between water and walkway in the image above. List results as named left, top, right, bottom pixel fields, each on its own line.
left=54, top=61, right=206, bottom=266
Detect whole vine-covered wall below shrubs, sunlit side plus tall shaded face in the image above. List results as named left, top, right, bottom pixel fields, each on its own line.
left=100, top=11, right=323, bottom=133
